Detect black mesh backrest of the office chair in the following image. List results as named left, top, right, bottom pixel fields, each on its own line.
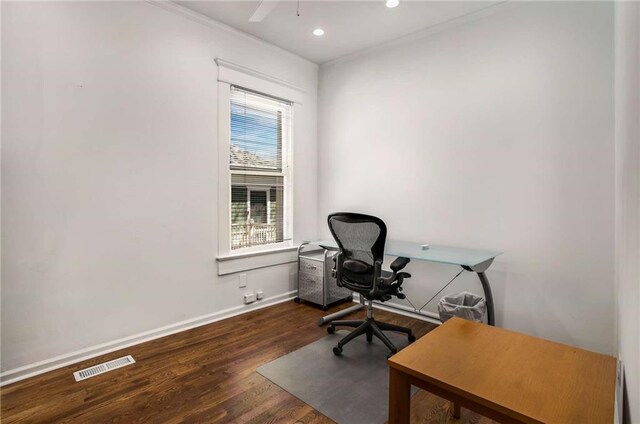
left=328, top=212, right=387, bottom=285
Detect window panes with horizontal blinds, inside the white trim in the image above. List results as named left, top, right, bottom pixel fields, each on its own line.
left=229, top=86, right=293, bottom=251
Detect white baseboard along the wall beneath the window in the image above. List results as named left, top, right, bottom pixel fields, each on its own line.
left=0, top=290, right=298, bottom=387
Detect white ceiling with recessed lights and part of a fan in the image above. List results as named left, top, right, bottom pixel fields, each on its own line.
left=176, top=0, right=498, bottom=63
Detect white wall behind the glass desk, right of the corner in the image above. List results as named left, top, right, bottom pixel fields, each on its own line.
left=318, top=2, right=614, bottom=353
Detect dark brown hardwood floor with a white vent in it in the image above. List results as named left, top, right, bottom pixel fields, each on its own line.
left=0, top=301, right=498, bottom=424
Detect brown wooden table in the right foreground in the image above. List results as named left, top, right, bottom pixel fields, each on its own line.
left=389, top=318, right=617, bottom=424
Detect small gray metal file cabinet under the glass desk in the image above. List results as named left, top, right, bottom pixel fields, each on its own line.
left=295, top=243, right=353, bottom=310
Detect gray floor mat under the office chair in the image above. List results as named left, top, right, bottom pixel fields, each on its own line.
left=258, top=330, right=415, bottom=424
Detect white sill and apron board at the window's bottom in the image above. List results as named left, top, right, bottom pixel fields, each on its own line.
left=216, top=246, right=298, bottom=275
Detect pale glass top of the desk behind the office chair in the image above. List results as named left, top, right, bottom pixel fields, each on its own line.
left=310, top=240, right=502, bottom=267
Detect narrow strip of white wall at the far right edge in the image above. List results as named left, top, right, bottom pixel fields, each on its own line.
left=615, top=2, right=640, bottom=423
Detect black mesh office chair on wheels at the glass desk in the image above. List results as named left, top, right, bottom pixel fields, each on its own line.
left=327, top=212, right=416, bottom=355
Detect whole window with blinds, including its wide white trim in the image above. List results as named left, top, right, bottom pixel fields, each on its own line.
left=216, top=58, right=302, bottom=268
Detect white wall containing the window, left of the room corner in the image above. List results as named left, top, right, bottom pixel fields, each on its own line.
left=2, top=2, right=318, bottom=370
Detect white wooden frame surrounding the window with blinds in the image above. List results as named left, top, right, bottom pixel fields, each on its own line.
left=216, top=58, right=304, bottom=264
